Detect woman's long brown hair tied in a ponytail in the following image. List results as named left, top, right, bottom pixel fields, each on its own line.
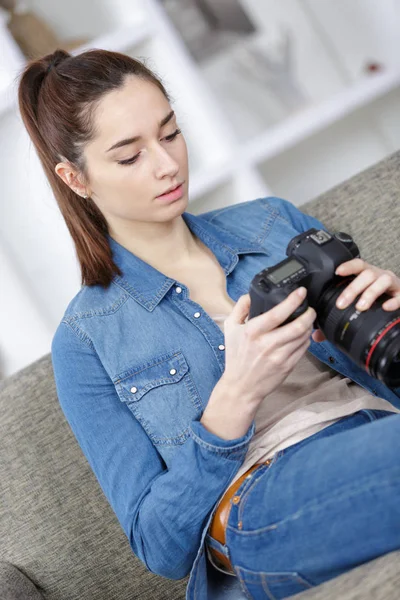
left=18, top=49, right=170, bottom=288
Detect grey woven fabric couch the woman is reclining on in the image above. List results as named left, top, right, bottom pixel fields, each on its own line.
left=0, top=153, right=400, bottom=600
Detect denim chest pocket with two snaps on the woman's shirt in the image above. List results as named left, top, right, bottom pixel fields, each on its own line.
left=113, top=351, right=203, bottom=445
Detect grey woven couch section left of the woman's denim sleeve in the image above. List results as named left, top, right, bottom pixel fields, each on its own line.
left=0, top=354, right=186, bottom=600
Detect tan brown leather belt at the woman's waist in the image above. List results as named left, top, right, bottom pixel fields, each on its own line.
left=207, top=459, right=272, bottom=575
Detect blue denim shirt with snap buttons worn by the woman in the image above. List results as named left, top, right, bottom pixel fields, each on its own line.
left=51, top=197, right=400, bottom=600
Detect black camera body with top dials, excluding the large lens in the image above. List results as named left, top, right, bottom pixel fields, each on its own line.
left=249, top=227, right=360, bottom=328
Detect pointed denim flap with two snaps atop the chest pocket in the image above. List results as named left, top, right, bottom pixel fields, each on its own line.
left=114, top=352, right=189, bottom=402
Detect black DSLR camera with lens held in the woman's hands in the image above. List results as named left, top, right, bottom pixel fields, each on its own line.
left=248, top=227, right=400, bottom=388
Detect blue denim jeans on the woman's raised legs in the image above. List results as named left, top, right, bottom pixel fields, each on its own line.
left=219, top=409, right=400, bottom=600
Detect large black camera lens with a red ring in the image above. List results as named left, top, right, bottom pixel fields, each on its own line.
left=315, top=276, right=400, bottom=387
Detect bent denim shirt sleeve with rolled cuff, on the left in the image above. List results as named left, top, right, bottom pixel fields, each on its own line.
left=51, top=321, right=255, bottom=579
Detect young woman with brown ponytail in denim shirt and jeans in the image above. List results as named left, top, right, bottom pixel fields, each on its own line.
left=19, top=50, right=400, bottom=599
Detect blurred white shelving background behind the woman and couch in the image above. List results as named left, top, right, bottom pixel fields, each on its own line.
left=0, top=0, right=400, bottom=379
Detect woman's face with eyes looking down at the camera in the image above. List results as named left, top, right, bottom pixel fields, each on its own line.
left=84, top=76, right=188, bottom=232
